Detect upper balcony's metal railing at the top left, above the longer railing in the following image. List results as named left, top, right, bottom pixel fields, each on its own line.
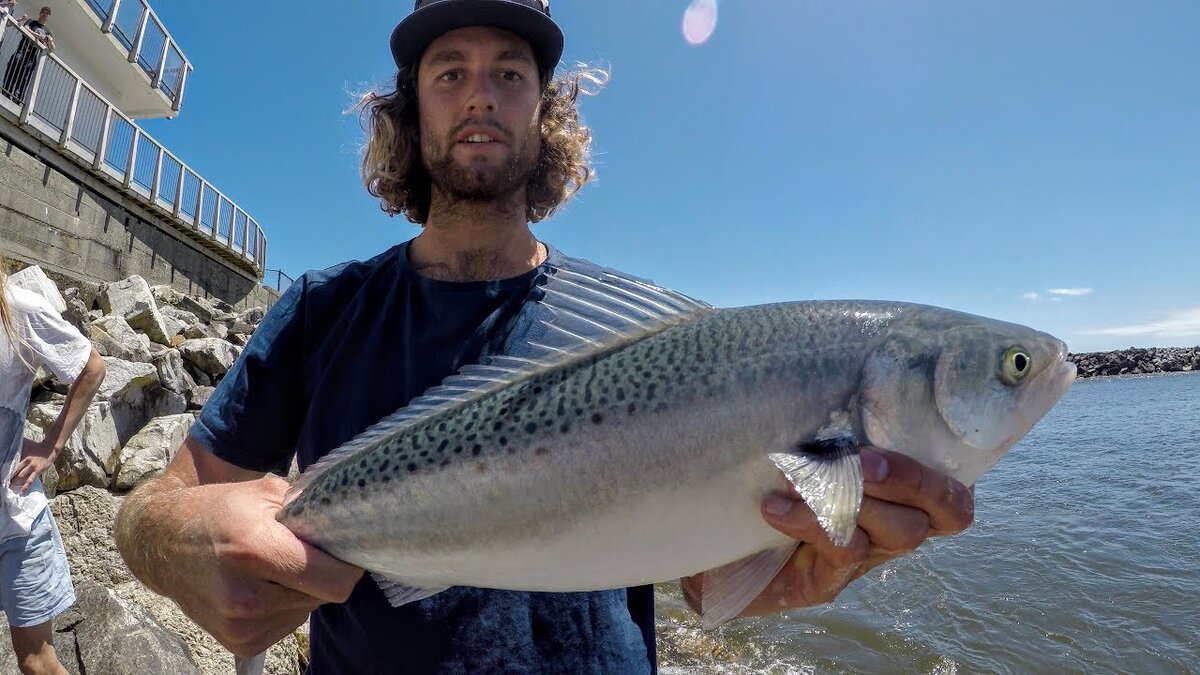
left=88, top=0, right=192, bottom=110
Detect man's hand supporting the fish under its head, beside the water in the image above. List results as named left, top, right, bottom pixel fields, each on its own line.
left=680, top=448, right=974, bottom=616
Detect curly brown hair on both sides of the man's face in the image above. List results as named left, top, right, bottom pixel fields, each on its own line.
left=358, top=66, right=608, bottom=225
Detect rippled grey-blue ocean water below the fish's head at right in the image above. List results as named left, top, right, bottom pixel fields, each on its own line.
left=658, top=374, right=1200, bottom=675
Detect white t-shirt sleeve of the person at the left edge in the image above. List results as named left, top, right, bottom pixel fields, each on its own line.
left=17, top=293, right=91, bottom=384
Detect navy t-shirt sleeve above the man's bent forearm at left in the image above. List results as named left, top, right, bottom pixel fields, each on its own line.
left=190, top=277, right=308, bottom=472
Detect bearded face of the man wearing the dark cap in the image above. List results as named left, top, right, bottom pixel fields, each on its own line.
left=416, top=26, right=541, bottom=201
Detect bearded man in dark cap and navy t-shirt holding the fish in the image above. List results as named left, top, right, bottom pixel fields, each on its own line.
left=116, top=0, right=972, bottom=675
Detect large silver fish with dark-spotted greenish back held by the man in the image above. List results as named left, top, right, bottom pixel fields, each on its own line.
left=280, top=270, right=1075, bottom=626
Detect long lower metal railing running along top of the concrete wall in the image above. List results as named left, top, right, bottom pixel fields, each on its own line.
left=0, top=18, right=266, bottom=275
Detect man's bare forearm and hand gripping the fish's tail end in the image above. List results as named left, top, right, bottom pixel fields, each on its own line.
left=115, top=438, right=362, bottom=656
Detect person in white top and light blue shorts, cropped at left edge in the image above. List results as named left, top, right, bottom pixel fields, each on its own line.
left=0, top=267, right=104, bottom=675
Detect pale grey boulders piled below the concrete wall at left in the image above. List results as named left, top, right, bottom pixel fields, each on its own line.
left=0, top=268, right=302, bottom=675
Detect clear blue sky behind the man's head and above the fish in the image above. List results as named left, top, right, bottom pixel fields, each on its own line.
left=131, top=0, right=1200, bottom=352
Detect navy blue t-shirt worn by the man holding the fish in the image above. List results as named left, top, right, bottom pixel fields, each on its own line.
left=191, top=244, right=656, bottom=675
